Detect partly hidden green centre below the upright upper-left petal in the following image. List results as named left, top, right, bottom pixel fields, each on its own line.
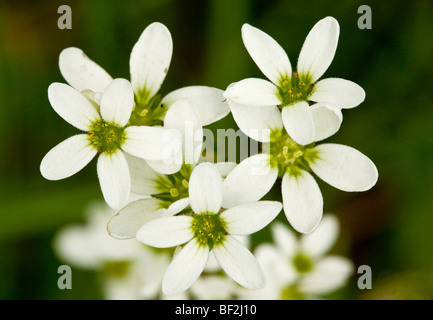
left=129, top=90, right=167, bottom=126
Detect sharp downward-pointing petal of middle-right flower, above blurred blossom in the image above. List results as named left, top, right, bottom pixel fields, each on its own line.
left=281, top=171, right=323, bottom=233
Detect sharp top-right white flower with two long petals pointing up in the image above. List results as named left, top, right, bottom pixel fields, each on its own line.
left=224, top=17, right=365, bottom=145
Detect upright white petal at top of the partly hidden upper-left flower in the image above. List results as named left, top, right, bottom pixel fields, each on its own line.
left=129, top=22, right=173, bottom=97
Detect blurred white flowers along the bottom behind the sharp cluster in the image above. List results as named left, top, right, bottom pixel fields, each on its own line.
left=53, top=201, right=354, bottom=300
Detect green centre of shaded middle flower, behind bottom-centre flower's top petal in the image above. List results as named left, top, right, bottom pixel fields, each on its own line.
left=153, top=164, right=192, bottom=208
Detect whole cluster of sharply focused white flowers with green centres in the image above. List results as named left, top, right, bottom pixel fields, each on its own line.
left=40, top=17, right=378, bottom=295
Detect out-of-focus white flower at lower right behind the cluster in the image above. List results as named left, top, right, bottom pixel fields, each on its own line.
left=241, top=214, right=354, bottom=300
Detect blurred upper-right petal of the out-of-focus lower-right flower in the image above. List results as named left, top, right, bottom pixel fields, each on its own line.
left=300, top=214, right=340, bottom=257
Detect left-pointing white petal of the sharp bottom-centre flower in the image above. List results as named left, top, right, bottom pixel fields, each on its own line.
left=136, top=216, right=193, bottom=248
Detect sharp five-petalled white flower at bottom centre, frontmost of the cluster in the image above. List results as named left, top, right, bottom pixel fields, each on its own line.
left=137, top=163, right=281, bottom=294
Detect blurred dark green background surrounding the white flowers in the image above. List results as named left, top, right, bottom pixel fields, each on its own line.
left=0, top=0, right=433, bottom=299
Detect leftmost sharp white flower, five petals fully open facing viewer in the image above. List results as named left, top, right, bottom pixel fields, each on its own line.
left=40, top=79, right=181, bottom=209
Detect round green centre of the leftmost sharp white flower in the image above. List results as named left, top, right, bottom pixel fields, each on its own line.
left=89, top=120, right=126, bottom=154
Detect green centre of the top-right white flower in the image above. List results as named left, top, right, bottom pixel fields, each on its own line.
left=277, top=72, right=314, bottom=107
